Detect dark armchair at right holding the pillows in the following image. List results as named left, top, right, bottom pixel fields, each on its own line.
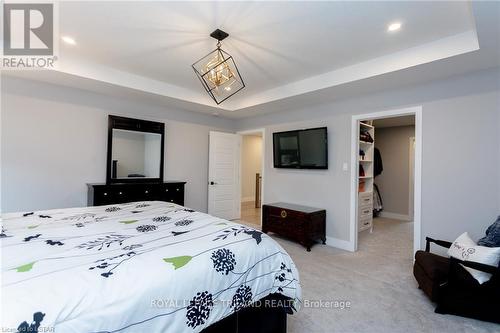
left=413, top=237, right=500, bottom=323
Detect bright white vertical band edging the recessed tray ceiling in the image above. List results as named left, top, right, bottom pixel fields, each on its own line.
left=13, top=29, right=479, bottom=113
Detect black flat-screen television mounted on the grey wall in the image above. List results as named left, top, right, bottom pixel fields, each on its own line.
left=273, top=127, right=328, bottom=169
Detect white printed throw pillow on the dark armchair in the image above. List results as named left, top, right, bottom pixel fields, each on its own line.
left=448, top=232, right=500, bottom=284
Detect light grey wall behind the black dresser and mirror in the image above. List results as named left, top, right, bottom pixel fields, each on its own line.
left=1, top=76, right=234, bottom=212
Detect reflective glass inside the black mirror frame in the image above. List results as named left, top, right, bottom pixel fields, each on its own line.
left=111, top=128, right=162, bottom=179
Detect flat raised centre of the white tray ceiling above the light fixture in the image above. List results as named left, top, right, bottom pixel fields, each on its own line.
left=60, top=2, right=474, bottom=94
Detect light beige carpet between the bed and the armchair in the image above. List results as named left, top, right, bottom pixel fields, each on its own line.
left=235, top=218, right=500, bottom=333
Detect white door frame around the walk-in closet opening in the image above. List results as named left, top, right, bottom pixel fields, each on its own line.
left=349, top=106, right=422, bottom=252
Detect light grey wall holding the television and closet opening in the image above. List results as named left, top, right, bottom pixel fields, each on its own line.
left=238, top=71, right=500, bottom=249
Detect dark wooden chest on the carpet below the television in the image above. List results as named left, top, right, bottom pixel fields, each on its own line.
left=262, top=202, right=326, bottom=251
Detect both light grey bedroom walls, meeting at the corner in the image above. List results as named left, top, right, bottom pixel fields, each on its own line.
left=1, top=70, right=500, bottom=252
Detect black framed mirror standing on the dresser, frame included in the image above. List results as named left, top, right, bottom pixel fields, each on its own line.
left=106, top=115, right=165, bottom=184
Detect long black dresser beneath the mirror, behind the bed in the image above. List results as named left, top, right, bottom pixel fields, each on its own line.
left=87, top=181, right=186, bottom=206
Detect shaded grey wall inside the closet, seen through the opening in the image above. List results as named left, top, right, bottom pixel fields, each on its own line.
left=375, top=126, right=415, bottom=217
